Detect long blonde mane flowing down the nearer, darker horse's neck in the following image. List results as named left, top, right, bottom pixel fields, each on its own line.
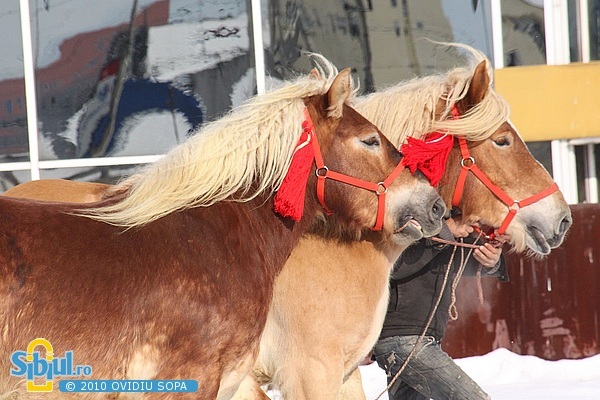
left=80, top=54, right=350, bottom=228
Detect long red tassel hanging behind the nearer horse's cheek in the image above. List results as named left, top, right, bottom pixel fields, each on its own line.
left=274, top=121, right=315, bottom=221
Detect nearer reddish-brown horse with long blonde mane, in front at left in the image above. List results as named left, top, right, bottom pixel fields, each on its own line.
left=0, top=70, right=445, bottom=399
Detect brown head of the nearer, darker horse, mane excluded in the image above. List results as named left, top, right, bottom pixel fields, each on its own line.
left=306, top=69, right=446, bottom=240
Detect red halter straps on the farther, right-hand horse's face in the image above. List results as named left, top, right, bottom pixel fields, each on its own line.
left=452, top=138, right=558, bottom=240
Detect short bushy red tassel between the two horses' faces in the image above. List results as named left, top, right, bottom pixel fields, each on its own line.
left=400, top=132, right=454, bottom=187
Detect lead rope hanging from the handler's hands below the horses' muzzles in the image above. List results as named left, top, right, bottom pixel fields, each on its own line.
left=375, top=233, right=481, bottom=400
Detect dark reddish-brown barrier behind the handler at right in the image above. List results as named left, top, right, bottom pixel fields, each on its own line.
left=443, top=204, right=600, bottom=360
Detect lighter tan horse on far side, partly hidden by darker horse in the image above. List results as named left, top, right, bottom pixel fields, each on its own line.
left=230, top=47, right=572, bottom=400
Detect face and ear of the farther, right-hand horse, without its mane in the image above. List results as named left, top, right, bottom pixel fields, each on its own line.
left=440, top=60, right=572, bottom=255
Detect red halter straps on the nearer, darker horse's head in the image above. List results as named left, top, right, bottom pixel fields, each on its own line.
left=304, top=109, right=404, bottom=231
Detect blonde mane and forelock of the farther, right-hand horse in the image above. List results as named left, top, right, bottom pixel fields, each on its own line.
left=352, top=43, right=509, bottom=146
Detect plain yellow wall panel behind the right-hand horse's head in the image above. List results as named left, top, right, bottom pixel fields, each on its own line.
left=494, top=62, right=600, bottom=141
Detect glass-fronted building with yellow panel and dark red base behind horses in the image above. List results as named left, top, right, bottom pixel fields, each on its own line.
left=0, top=0, right=600, bottom=358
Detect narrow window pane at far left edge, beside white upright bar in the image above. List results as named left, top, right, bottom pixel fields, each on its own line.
left=0, top=0, right=29, bottom=162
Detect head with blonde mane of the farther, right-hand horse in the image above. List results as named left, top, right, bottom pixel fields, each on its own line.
left=352, top=43, right=572, bottom=255
